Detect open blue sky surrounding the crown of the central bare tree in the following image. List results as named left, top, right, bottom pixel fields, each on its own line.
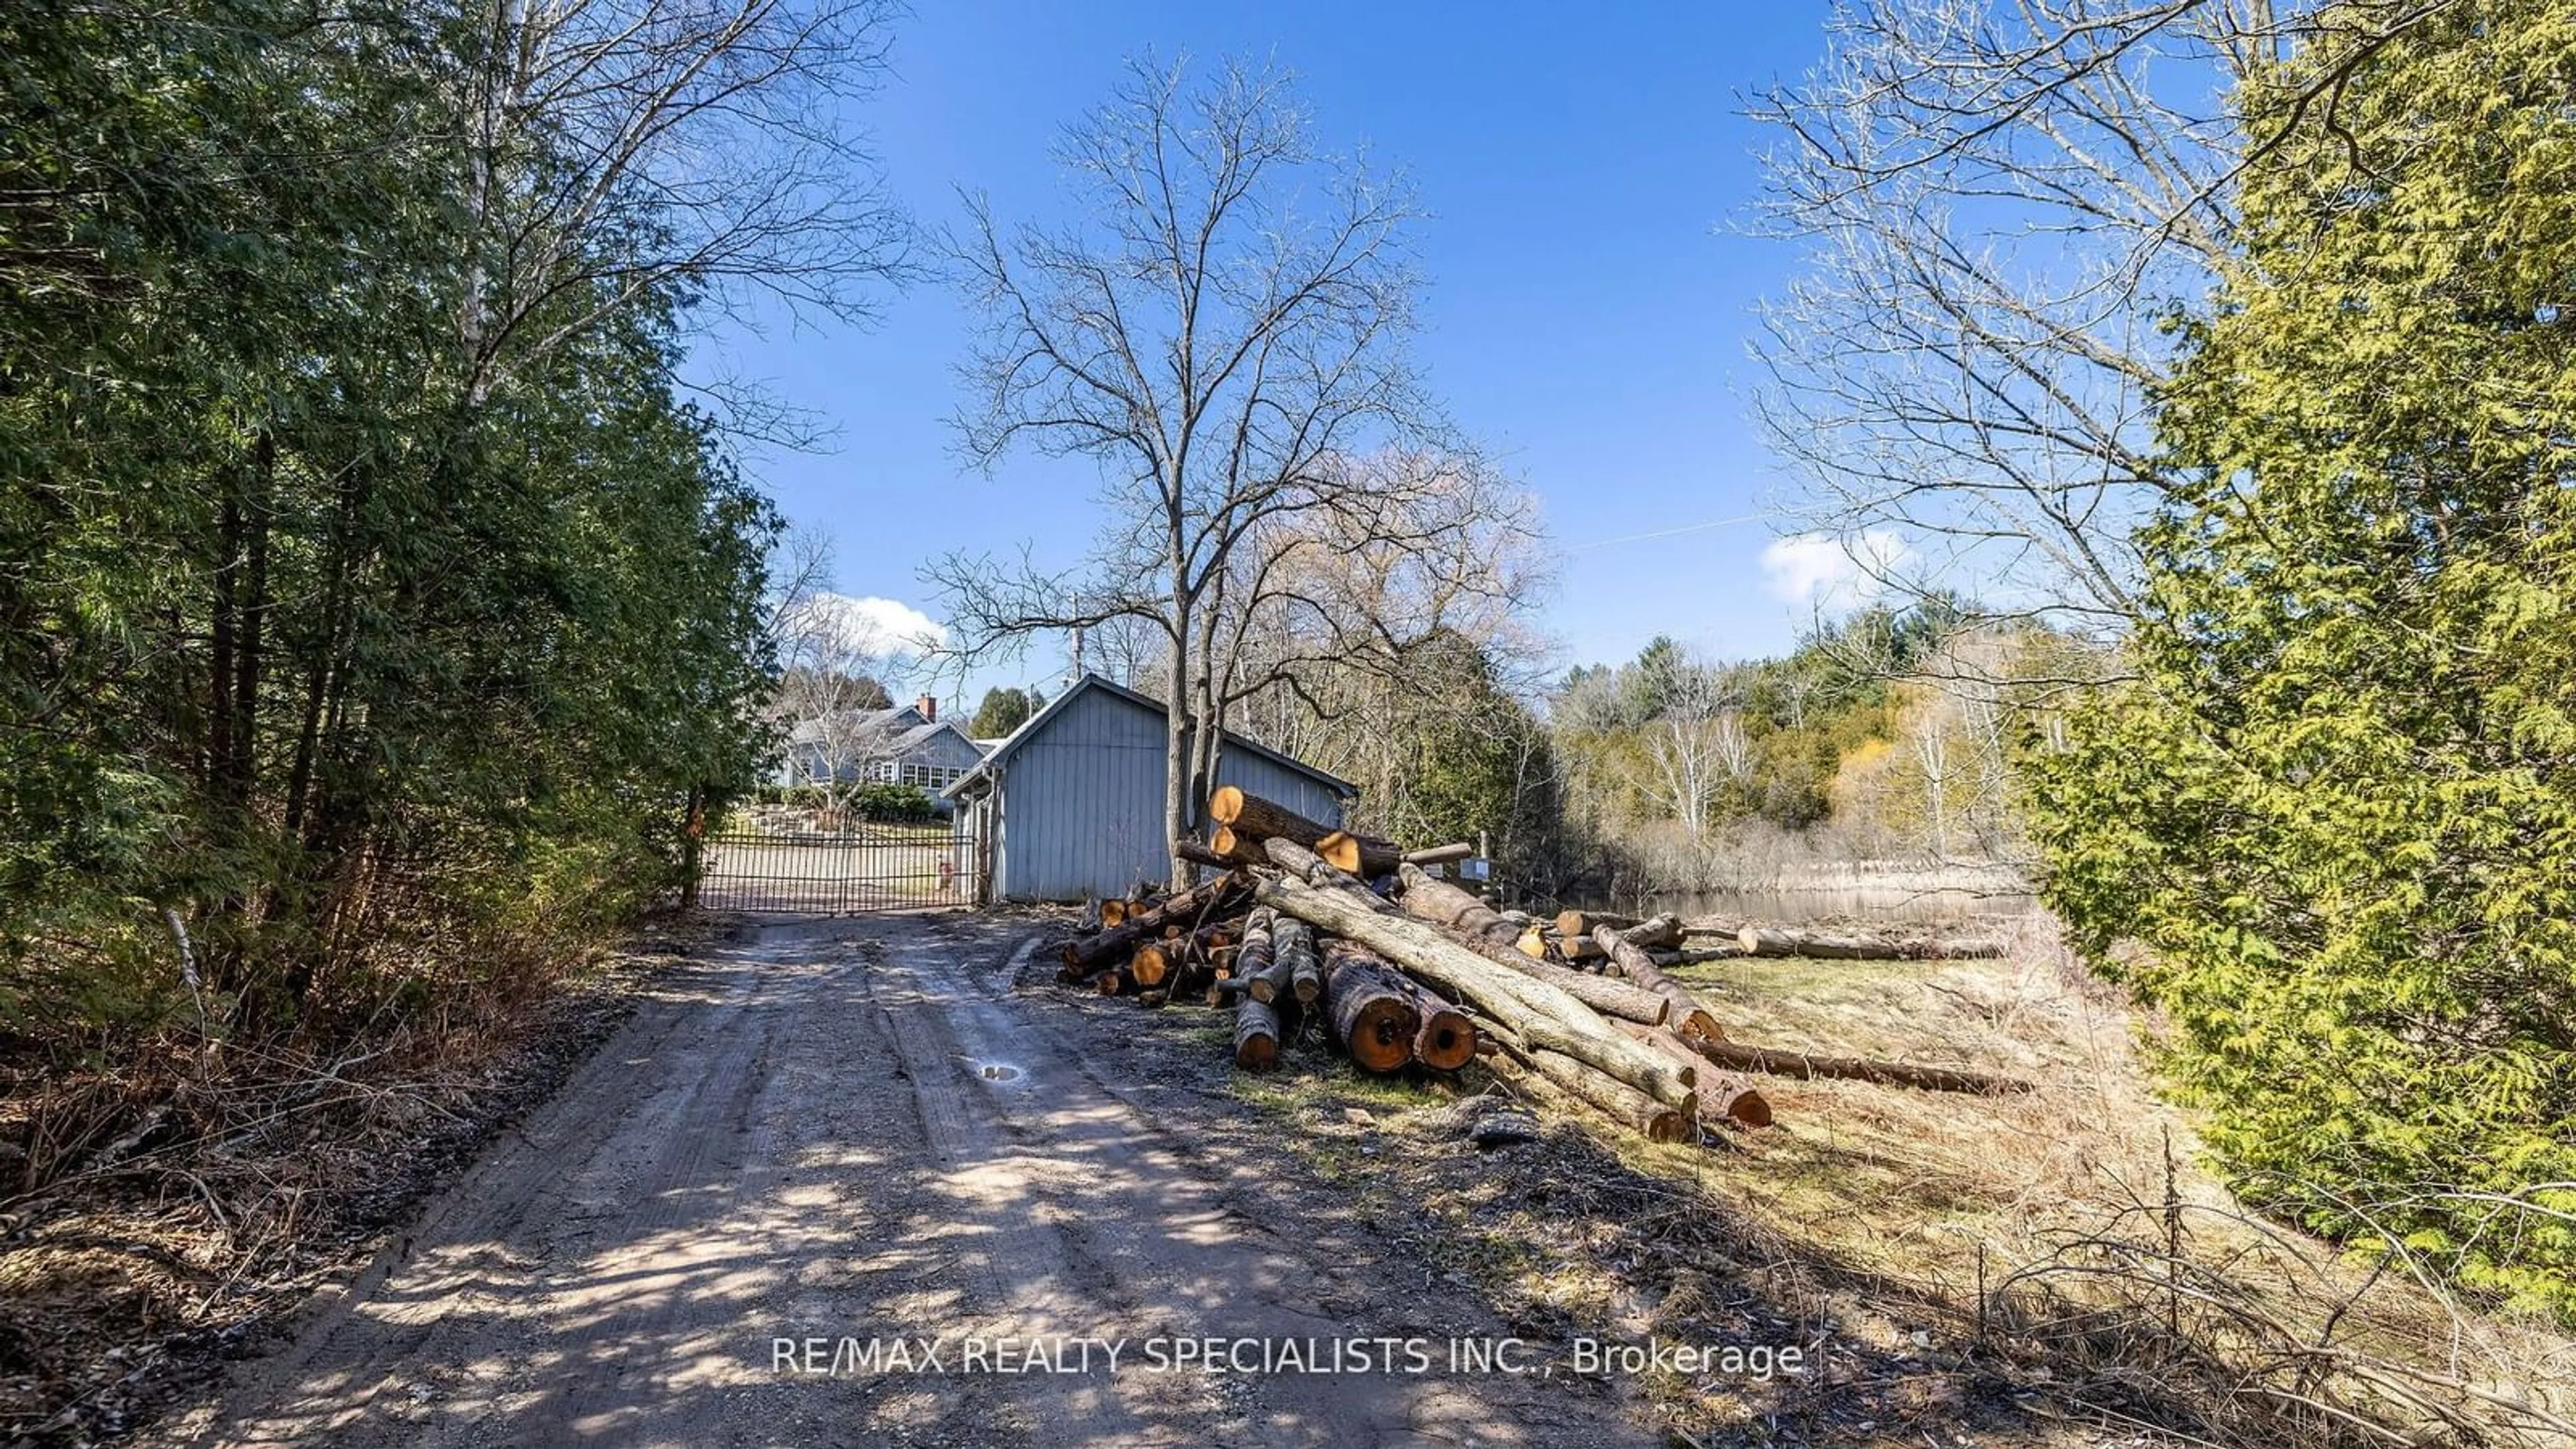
left=700, top=0, right=1827, bottom=694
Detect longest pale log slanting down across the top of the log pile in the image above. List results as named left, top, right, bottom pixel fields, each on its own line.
left=1254, top=879, right=1693, bottom=1106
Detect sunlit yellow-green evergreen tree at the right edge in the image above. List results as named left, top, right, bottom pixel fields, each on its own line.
left=2035, top=0, right=2576, bottom=1312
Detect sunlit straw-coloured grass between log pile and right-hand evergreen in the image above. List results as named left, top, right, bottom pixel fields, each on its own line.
left=1648, top=918, right=2576, bottom=1449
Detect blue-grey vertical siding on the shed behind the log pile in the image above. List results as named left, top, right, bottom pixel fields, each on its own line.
left=991, top=688, right=1342, bottom=900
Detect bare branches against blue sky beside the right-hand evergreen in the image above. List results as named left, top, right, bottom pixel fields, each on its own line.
left=1754, top=0, right=2453, bottom=634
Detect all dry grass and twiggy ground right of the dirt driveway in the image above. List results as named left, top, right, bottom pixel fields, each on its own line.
left=1205, top=907, right=2576, bottom=1449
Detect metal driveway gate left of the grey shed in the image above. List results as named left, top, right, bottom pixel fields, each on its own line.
left=698, top=815, right=984, bottom=915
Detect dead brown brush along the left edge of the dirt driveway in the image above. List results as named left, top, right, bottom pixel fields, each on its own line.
left=0, top=918, right=706, bottom=1444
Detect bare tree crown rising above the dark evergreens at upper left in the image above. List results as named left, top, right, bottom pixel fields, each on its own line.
left=456, top=0, right=907, bottom=402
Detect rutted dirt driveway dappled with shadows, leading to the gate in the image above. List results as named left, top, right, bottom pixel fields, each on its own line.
left=162, top=915, right=1651, bottom=1446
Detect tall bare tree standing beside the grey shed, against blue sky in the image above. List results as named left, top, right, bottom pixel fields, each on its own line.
left=930, top=64, right=1442, bottom=879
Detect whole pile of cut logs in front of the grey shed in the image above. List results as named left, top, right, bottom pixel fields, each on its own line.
left=1059, top=786, right=2022, bottom=1142
